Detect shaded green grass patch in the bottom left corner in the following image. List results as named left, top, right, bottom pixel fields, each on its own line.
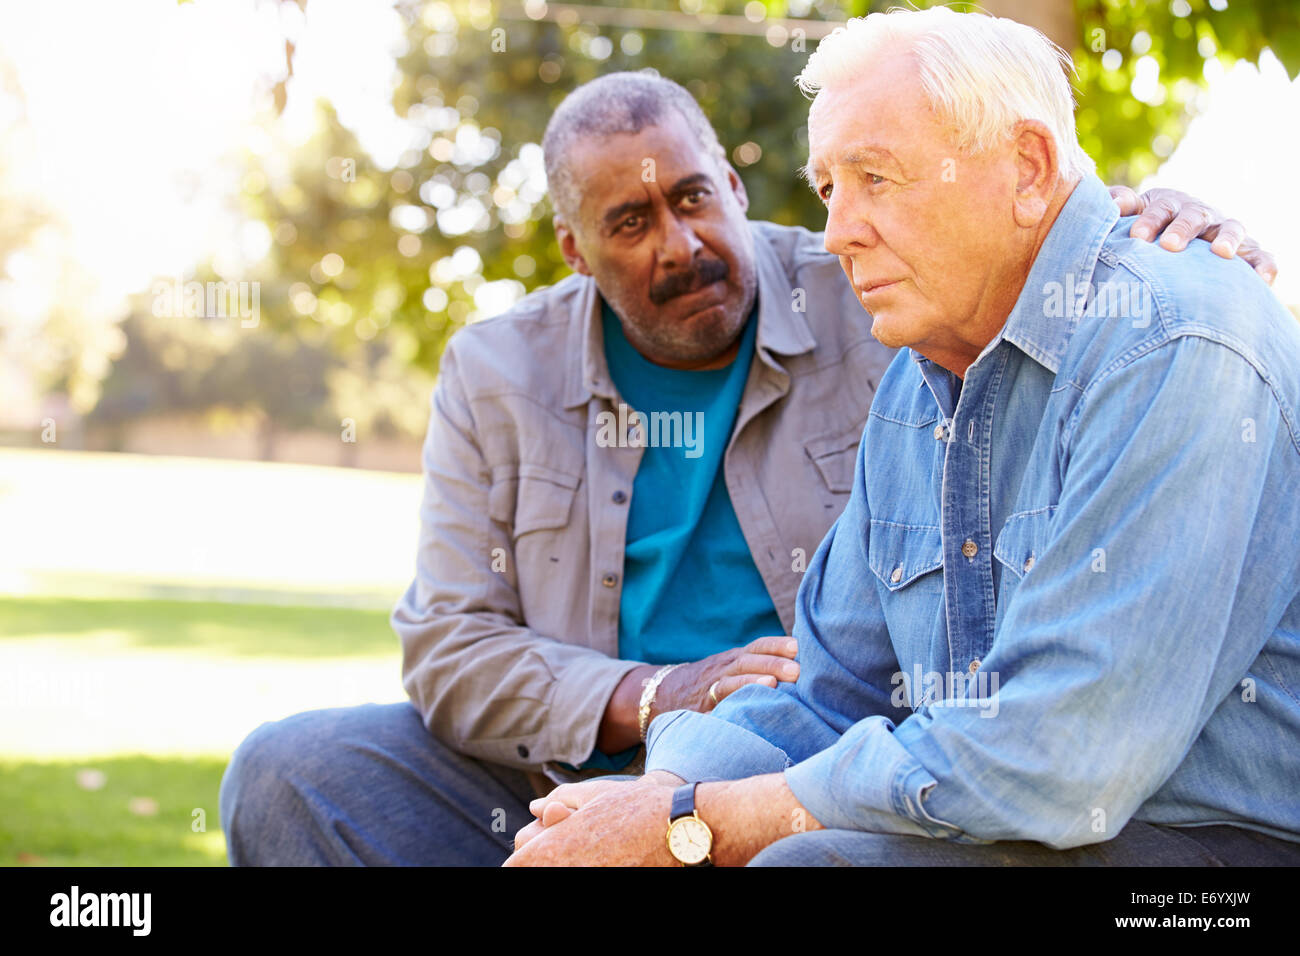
left=0, top=756, right=225, bottom=866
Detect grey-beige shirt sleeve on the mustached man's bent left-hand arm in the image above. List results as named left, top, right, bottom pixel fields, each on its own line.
left=391, top=339, right=637, bottom=767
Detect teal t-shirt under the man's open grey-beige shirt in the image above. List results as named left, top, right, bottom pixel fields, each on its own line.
left=584, top=303, right=785, bottom=770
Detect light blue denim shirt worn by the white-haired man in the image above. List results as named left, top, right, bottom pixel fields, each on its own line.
left=646, top=177, right=1300, bottom=848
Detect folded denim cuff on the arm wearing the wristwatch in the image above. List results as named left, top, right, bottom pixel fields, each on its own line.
left=785, top=717, right=967, bottom=843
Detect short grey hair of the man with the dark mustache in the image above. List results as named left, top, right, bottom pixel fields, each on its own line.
left=542, top=70, right=727, bottom=222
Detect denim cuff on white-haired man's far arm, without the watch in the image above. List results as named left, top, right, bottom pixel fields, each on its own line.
left=646, top=710, right=792, bottom=780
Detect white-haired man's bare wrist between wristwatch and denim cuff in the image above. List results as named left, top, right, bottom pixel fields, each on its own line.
left=696, top=774, right=823, bottom=866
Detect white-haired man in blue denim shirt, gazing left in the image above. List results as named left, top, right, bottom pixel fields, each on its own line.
left=510, top=8, right=1300, bottom=865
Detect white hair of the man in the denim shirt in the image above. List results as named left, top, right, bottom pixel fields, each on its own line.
left=796, top=7, right=1096, bottom=179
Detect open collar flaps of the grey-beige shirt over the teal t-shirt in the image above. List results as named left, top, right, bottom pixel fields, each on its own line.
left=564, top=222, right=816, bottom=408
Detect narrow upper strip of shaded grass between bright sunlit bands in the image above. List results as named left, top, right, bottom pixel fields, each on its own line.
left=0, top=597, right=398, bottom=658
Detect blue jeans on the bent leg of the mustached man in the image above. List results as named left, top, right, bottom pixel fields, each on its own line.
left=220, top=704, right=537, bottom=866
